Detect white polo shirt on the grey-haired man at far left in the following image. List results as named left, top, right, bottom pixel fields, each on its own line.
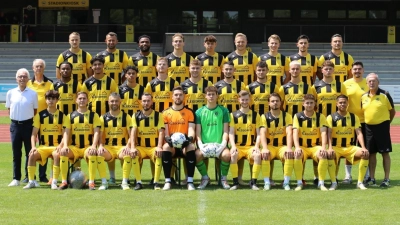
left=6, top=87, right=38, bottom=121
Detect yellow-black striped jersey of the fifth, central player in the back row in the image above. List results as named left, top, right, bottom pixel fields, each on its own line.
left=196, top=52, right=224, bottom=85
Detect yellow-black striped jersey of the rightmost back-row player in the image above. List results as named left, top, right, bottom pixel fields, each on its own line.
left=318, top=51, right=354, bottom=83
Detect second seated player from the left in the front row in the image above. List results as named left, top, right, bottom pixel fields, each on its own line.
left=53, top=92, right=101, bottom=190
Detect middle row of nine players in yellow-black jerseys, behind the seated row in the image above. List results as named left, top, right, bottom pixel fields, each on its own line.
left=46, top=57, right=360, bottom=185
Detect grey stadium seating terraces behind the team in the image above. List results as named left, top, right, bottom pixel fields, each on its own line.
left=0, top=42, right=400, bottom=85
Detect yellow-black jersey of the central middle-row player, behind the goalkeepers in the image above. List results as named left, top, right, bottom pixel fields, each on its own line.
left=181, top=78, right=212, bottom=111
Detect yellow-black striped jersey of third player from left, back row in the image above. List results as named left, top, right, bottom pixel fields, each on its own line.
left=128, top=52, right=159, bottom=86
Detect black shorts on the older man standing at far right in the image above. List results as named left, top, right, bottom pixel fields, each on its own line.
left=365, top=120, right=392, bottom=154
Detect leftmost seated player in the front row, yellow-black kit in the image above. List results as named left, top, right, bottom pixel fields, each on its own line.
left=24, top=90, right=65, bottom=190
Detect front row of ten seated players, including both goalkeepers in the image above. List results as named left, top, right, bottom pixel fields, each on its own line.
left=24, top=86, right=368, bottom=190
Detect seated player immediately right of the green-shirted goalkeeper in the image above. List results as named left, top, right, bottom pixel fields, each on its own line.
left=229, top=90, right=261, bottom=191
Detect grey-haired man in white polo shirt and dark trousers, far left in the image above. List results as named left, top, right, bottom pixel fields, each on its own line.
left=6, top=68, right=38, bottom=187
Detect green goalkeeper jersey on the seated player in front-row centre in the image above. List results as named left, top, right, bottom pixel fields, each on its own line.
left=196, top=105, right=230, bottom=144
